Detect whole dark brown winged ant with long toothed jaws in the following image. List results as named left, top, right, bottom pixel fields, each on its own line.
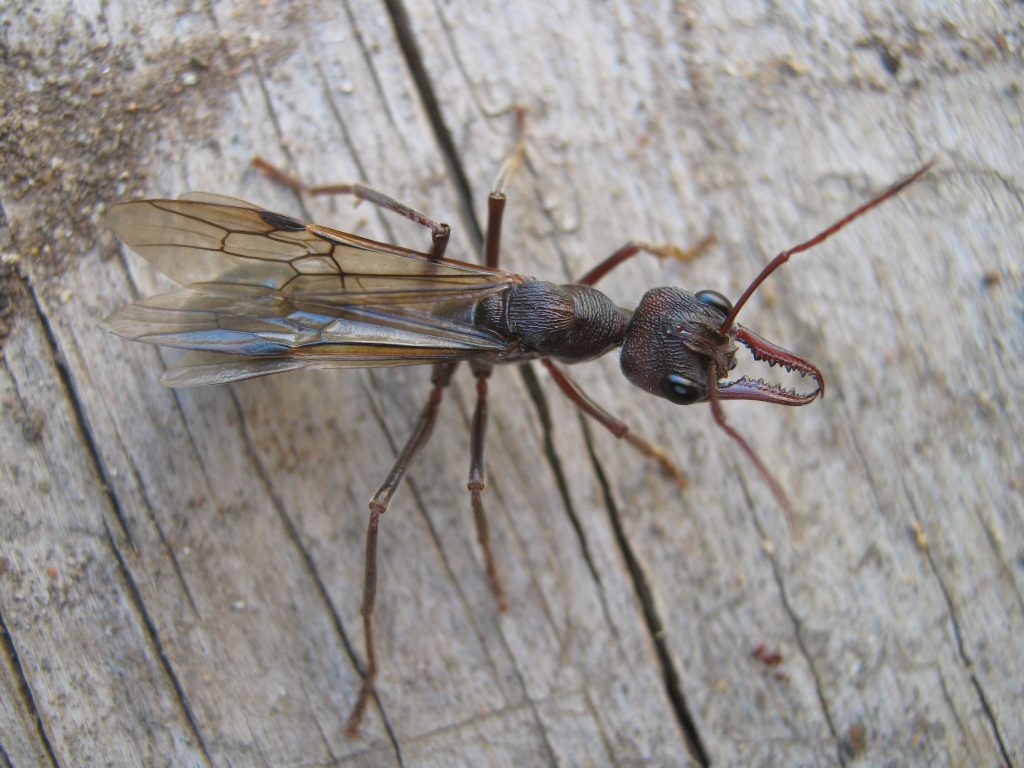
left=103, top=114, right=929, bottom=735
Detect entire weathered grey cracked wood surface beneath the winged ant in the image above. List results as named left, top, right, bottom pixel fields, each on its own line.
left=0, top=0, right=1024, bottom=766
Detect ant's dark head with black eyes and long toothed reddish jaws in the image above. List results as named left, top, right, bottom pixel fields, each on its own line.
left=620, top=288, right=824, bottom=406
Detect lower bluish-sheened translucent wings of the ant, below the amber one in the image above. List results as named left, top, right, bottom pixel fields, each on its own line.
left=100, top=283, right=508, bottom=386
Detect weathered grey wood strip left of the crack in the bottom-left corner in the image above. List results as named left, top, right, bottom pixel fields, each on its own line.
left=0, top=296, right=205, bottom=765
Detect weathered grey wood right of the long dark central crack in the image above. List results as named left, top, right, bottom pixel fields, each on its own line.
left=401, top=4, right=1022, bottom=765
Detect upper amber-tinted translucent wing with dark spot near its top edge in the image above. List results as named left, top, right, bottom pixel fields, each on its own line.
left=106, top=193, right=521, bottom=304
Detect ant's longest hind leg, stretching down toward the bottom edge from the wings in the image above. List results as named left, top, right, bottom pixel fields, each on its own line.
left=345, top=362, right=458, bottom=737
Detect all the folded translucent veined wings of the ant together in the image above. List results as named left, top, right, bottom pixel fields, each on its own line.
left=101, top=193, right=523, bottom=386
